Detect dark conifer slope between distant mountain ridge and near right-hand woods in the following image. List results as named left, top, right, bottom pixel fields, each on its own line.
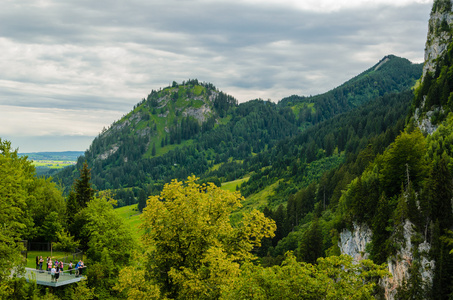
left=241, top=91, right=413, bottom=205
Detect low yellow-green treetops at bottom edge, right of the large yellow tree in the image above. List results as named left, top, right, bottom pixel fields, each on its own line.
left=221, top=254, right=388, bottom=299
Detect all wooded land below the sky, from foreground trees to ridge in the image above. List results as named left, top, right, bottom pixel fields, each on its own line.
left=0, top=0, right=453, bottom=299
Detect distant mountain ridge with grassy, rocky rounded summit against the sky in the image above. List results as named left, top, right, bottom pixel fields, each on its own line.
left=55, top=56, right=422, bottom=205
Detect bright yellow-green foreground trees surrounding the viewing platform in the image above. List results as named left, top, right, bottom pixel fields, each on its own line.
left=0, top=154, right=387, bottom=299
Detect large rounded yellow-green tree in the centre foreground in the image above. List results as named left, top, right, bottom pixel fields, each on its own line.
left=136, top=176, right=275, bottom=299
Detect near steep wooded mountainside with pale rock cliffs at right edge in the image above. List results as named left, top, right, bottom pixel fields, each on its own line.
left=258, top=0, right=453, bottom=299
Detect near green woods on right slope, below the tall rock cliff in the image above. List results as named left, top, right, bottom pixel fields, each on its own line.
left=258, top=103, right=453, bottom=299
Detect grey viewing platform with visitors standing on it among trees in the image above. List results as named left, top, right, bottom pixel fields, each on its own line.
left=24, top=267, right=86, bottom=287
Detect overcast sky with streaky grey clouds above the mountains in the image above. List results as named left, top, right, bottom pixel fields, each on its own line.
left=0, top=0, right=432, bottom=152
